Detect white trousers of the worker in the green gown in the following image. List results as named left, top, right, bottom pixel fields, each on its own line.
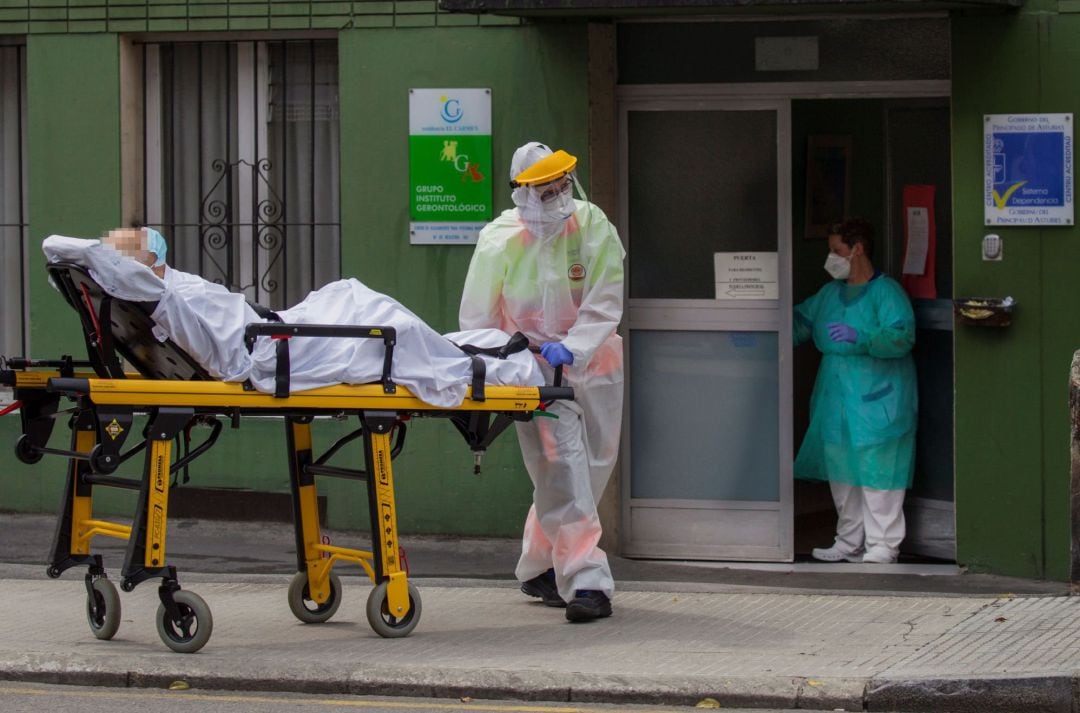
left=828, top=481, right=906, bottom=560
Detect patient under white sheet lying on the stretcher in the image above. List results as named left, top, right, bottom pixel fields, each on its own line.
left=42, top=229, right=544, bottom=407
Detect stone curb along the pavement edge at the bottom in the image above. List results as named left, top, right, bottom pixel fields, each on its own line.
left=6, top=655, right=1080, bottom=713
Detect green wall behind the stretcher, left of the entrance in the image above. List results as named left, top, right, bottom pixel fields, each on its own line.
left=8, top=19, right=588, bottom=536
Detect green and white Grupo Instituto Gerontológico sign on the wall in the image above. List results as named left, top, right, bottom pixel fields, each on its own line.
left=408, top=89, right=491, bottom=245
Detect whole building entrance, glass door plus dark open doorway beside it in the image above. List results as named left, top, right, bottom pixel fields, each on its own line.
left=619, top=81, right=955, bottom=562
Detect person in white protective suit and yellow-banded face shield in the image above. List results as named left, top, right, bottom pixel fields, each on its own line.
left=459, top=142, right=625, bottom=621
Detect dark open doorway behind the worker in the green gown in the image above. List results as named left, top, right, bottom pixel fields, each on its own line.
left=792, top=97, right=956, bottom=562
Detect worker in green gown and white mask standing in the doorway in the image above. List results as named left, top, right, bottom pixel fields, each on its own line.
left=794, top=218, right=918, bottom=563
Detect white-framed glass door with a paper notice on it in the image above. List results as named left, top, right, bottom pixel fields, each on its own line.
left=619, top=95, right=793, bottom=561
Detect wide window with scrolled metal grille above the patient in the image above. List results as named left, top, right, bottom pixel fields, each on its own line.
left=143, top=40, right=340, bottom=309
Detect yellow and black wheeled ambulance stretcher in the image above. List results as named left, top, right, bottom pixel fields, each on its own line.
left=0, top=264, right=573, bottom=654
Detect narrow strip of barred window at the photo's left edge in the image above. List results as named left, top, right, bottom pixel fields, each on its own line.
left=0, top=38, right=28, bottom=367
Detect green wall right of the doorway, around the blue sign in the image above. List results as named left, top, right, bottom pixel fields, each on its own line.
left=953, top=2, right=1080, bottom=580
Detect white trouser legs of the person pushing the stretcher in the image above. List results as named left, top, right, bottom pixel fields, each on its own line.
left=514, top=381, right=622, bottom=602
